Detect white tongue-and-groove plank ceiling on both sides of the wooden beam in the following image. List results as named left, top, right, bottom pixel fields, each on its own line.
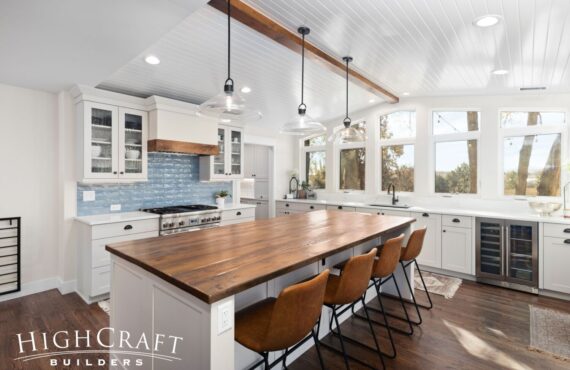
left=99, top=0, right=570, bottom=128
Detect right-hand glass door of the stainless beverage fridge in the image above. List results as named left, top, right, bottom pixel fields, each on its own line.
left=506, top=224, right=538, bottom=286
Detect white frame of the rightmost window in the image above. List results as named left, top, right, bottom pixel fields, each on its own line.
left=497, top=107, right=569, bottom=200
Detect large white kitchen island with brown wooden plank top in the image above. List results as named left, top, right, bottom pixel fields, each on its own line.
left=106, top=211, right=414, bottom=370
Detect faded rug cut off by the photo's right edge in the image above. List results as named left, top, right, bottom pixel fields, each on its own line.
left=529, top=305, right=570, bottom=361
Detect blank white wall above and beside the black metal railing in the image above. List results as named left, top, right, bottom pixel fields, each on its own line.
left=0, top=84, right=59, bottom=284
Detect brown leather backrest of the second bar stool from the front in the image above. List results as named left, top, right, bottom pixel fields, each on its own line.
left=326, top=248, right=378, bottom=304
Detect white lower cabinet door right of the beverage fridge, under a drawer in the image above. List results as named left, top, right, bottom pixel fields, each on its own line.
left=542, top=237, right=570, bottom=294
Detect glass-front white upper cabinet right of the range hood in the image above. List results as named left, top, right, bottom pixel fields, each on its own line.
left=200, top=125, right=244, bottom=181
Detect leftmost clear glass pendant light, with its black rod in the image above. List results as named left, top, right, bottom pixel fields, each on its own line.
left=198, top=0, right=261, bottom=123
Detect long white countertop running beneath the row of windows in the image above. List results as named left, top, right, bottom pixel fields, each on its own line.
left=277, top=199, right=570, bottom=225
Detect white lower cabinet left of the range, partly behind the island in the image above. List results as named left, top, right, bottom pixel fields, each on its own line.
left=76, top=218, right=158, bottom=303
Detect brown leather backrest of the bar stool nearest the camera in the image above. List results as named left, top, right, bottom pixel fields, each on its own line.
left=263, top=270, right=329, bottom=351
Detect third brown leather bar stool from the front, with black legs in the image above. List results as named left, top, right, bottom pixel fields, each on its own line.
left=355, top=234, right=414, bottom=358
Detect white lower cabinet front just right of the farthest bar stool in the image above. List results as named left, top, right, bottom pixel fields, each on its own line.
left=411, top=212, right=442, bottom=268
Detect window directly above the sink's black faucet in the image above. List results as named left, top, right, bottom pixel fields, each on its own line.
left=380, top=111, right=416, bottom=192
